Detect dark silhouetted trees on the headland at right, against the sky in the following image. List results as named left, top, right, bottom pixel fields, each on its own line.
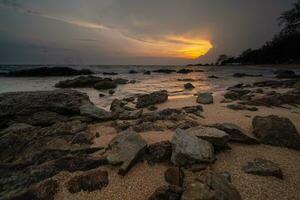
left=217, top=1, right=300, bottom=65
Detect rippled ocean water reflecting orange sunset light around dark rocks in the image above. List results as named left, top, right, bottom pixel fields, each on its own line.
left=0, top=65, right=300, bottom=109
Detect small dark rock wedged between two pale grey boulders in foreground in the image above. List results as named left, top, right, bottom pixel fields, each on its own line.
left=145, top=141, right=172, bottom=164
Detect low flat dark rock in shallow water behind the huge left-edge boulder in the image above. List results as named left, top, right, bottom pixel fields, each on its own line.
left=55, top=76, right=103, bottom=88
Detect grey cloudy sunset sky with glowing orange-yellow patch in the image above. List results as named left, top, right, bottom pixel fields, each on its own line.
left=0, top=0, right=295, bottom=65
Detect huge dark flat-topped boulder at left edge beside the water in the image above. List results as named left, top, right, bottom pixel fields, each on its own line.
left=0, top=90, right=91, bottom=127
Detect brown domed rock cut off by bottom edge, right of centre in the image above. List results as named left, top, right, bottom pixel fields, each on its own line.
left=181, top=170, right=242, bottom=200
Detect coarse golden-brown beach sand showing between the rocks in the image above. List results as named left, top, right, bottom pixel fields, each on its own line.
left=55, top=92, right=300, bottom=200
